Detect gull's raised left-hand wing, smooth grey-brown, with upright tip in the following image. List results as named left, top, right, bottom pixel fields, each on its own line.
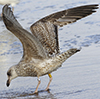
left=2, top=5, right=46, bottom=60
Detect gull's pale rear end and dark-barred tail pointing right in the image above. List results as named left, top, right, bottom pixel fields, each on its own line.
left=45, top=48, right=81, bottom=74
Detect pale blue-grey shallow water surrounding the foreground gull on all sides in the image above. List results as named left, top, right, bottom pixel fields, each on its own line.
left=0, top=0, right=100, bottom=99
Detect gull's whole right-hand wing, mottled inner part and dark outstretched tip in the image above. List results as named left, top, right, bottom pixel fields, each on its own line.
left=30, top=4, right=98, bottom=56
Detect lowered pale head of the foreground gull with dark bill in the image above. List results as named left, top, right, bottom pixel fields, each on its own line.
left=6, top=66, right=18, bottom=87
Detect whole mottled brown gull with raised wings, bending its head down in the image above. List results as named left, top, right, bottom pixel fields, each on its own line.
left=2, top=4, right=98, bottom=93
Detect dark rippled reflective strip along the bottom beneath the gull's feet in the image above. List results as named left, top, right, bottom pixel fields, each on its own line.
left=0, top=89, right=88, bottom=99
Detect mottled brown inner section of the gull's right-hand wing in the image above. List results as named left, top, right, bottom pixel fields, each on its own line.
left=30, top=22, right=59, bottom=56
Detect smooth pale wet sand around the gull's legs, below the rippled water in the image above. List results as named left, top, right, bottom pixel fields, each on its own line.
left=0, top=45, right=100, bottom=99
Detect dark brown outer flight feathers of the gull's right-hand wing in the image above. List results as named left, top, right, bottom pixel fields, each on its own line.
left=39, top=4, right=98, bottom=26
